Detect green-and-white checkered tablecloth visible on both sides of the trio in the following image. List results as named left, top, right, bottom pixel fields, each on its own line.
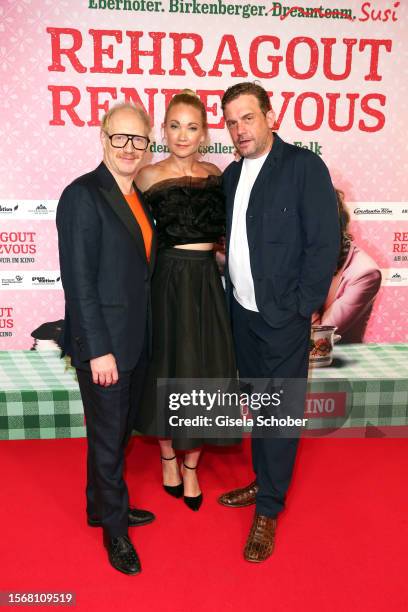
left=0, top=344, right=408, bottom=440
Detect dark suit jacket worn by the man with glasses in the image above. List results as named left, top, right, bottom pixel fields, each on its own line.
left=57, top=163, right=156, bottom=371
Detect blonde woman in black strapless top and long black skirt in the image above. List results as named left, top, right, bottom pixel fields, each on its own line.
left=136, top=90, right=237, bottom=510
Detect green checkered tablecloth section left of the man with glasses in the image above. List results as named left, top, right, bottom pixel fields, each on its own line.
left=0, top=351, right=86, bottom=440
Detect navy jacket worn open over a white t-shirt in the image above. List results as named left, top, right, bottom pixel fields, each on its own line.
left=223, top=134, right=340, bottom=328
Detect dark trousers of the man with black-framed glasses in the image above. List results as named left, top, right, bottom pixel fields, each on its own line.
left=77, top=342, right=147, bottom=538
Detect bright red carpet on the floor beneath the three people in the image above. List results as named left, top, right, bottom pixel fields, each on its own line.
left=0, top=439, right=408, bottom=612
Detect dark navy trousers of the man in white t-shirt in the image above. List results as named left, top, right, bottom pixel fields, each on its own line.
left=232, top=299, right=310, bottom=516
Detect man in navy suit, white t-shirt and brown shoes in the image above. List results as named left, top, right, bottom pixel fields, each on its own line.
left=219, top=83, right=339, bottom=562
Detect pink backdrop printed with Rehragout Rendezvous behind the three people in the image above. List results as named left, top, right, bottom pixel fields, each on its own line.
left=0, top=0, right=408, bottom=350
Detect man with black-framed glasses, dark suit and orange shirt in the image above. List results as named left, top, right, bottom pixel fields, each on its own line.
left=57, top=104, right=155, bottom=574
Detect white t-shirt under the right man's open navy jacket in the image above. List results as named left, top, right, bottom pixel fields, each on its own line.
left=228, top=151, right=269, bottom=312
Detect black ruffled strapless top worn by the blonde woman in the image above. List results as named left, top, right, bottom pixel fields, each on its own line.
left=143, top=175, right=225, bottom=248
